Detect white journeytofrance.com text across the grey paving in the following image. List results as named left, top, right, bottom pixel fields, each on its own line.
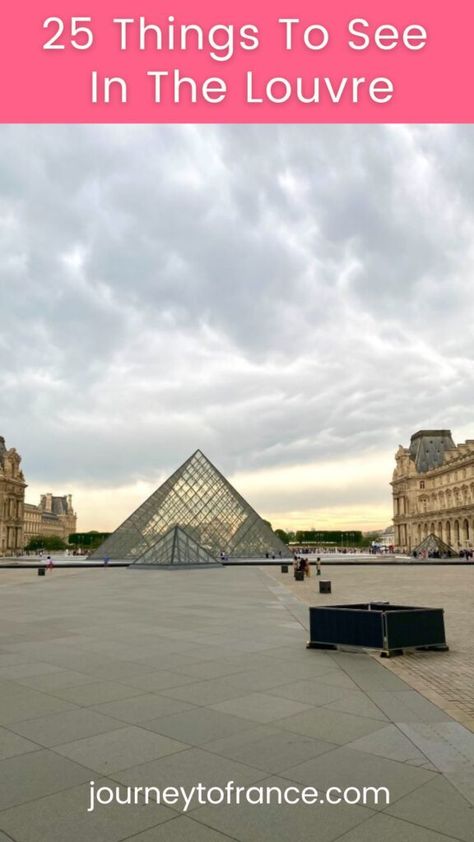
left=87, top=781, right=390, bottom=813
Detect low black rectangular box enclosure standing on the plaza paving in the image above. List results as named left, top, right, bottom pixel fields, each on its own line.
left=308, top=602, right=449, bottom=657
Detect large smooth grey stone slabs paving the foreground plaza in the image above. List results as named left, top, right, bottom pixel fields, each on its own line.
left=0, top=568, right=474, bottom=842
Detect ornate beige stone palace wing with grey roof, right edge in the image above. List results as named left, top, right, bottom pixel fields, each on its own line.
left=391, top=430, right=474, bottom=553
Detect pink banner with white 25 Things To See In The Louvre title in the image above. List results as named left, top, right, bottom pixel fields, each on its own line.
left=0, top=0, right=474, bottom=123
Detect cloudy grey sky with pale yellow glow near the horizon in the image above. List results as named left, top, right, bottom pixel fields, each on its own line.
left=0, top=126, right=474, bottom=529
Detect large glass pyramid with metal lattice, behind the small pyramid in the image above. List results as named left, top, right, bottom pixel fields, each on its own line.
left=92, top=450, right=290, bottom=561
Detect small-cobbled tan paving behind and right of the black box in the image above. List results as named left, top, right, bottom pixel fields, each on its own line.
left=267, top=565, right=474, bottom=731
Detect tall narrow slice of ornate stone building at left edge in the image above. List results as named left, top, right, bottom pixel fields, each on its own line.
left=0, top=436, right=26, bottom=555
